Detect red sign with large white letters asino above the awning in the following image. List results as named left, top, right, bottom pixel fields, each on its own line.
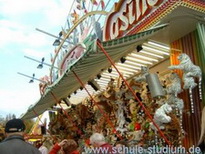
left=103, top=0, right=164, bottom=41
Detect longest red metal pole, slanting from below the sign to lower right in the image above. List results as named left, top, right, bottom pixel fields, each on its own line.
left=97, top=40, right=171, bottom=145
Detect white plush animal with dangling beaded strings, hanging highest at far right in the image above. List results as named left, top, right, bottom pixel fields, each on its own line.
left=169, top=53, right=202, bottom=113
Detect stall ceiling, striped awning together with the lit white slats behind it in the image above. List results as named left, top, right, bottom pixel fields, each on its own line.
left=22, top=25, right=169, bottom=119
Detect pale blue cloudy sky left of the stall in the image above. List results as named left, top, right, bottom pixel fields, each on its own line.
left=0, top=0, right=73, bottom=117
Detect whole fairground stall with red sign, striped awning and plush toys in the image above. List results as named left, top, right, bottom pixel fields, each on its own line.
left=22, top=0, right=205, bottom=148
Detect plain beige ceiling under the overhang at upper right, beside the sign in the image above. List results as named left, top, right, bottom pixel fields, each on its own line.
left=152, top=6, right=205, bottom=44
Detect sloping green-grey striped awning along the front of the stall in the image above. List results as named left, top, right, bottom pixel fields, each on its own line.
left=22, top=24, right=167, bottom=119
